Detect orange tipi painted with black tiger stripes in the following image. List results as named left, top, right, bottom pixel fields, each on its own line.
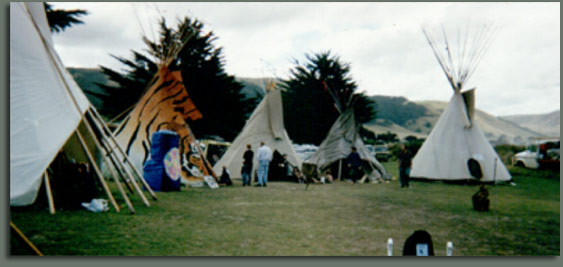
left=114, top=31, right=217, bottom=182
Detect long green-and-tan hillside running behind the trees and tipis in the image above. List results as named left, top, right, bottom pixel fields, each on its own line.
left=69, top=68, right=559, bottom=144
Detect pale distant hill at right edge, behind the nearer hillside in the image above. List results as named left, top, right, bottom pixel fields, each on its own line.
left=501, top=110, right=561, bottom=136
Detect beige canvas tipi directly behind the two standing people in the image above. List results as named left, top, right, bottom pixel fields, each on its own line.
left=213, top=88, right=301, bottom=178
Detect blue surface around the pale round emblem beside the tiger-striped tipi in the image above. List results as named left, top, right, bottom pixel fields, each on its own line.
left=143, top=130, right=180, bottom=192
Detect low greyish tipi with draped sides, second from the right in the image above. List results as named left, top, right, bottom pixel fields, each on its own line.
left=305, top=106, right=390, bottom=179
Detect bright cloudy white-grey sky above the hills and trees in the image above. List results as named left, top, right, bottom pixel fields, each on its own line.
left=53, top=2, right=560, bottom=115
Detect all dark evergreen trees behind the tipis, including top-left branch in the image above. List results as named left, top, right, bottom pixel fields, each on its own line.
left=46, top=4, right=376, bottom=145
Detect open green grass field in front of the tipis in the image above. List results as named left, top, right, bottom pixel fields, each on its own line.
left=10, top=162, right=560, bottom=256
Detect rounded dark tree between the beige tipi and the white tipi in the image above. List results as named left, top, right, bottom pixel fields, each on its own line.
left=281, top=51, right=375, bottom=145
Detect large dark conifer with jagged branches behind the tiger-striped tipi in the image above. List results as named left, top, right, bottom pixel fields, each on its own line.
left=99, top=17, right=254, bottom=140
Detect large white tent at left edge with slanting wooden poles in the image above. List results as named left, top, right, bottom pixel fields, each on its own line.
left=10, top=2, right=155, bottom=216
